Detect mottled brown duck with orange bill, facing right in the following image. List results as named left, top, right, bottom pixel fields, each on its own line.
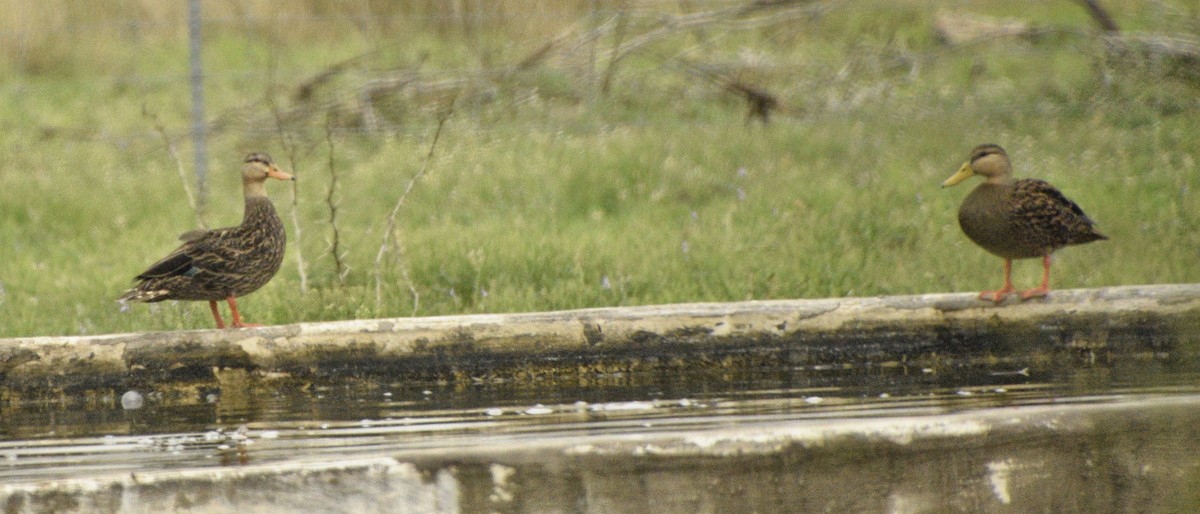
left=118, top=154, right=295, bottom=328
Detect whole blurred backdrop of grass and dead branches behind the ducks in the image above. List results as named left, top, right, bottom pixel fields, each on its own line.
left=0, top=0, right=1200, bottom=336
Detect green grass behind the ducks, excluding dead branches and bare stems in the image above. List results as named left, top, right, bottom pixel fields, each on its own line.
left=0, top=1, right=1200, bottom=336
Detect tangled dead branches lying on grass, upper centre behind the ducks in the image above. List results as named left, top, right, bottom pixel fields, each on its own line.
left=225, top=0, right=833, bottom=131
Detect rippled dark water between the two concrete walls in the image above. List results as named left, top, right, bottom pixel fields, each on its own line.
left=0, top=355, right=1200, bottom=484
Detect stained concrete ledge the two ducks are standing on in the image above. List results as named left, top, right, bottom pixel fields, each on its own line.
left=0, top=285, right=1200, bottom=395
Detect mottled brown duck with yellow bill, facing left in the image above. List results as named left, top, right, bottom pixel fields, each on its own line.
left=942, top=144, right=1108, bottom=303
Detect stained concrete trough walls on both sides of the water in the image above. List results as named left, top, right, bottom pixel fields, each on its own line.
left=0, top=285, right=1200, bottom=513
